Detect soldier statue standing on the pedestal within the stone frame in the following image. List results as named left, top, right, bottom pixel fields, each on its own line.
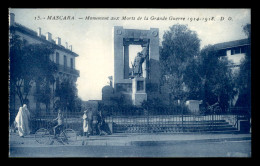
left=132, top=45, right=148, bottom=77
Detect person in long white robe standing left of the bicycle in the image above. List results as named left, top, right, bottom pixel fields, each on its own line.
left=15, top=104, right=30, bottom=137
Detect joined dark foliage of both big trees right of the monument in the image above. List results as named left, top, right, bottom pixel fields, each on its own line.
left=160, top=24, right=237, bottom=110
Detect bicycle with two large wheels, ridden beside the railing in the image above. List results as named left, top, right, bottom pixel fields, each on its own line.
left=34, top=122, right=77, bottom=145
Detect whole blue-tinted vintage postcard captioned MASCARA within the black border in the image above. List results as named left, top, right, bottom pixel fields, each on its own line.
left=8, top=8, right=252, bottom=158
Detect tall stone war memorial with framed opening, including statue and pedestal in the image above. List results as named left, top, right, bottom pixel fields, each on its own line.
left=113, top=26, right=160, bottom=106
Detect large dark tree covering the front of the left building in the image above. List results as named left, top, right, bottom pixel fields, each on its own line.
left=10, top=30, right=57, bottom=109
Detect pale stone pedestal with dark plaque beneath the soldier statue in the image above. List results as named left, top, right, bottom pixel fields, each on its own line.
left=132, top=77, right=147, bottom=106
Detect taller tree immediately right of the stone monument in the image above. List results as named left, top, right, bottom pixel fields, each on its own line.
left=160, top=24, right=200, bottom=101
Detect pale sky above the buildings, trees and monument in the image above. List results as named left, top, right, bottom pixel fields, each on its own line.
left=9, top=8, right=251, bottom=101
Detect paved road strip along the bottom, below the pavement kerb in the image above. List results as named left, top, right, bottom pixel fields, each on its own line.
left=10, top=140, right=251, bottom=157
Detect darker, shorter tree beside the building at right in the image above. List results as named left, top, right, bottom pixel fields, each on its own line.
left=199, top=45, right=237, bottom=111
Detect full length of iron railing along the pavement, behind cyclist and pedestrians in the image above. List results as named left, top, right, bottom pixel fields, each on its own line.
left=12, top=108, right=250, bottom=132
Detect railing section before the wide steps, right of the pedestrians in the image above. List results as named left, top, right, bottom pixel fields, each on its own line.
left=106, top=114, right=241, bottom=132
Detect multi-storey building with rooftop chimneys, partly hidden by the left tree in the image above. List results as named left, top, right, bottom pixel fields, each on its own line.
left=9, top=13, right=79, bottom=116
